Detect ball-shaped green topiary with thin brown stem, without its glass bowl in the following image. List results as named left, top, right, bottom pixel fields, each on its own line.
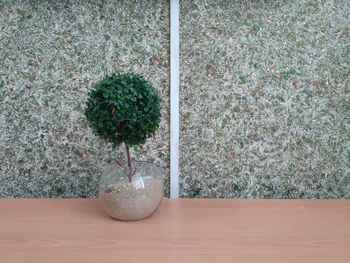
left=85, top=73, right=161, bottom=182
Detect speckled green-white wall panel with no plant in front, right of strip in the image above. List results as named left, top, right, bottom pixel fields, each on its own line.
left=180, top=0, right=350, bottom=198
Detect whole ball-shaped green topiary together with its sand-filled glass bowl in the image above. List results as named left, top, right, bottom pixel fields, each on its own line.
left=85, top=73, right=163, bottom=220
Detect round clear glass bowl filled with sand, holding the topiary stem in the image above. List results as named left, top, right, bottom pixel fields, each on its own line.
left=98, top=161, right=163, bottom=221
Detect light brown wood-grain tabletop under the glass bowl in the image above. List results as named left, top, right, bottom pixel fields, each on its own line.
left=0, top=199, right=350, bottom=263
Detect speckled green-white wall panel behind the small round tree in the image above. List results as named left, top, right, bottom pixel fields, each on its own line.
left=0, top=1, right=169, bottom=197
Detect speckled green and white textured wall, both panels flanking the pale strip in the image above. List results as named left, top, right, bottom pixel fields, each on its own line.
left=0, top=0, right=350, bottom=198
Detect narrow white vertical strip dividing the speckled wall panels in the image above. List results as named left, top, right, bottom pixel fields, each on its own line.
left=170, top=0, right=180, bottom=198
